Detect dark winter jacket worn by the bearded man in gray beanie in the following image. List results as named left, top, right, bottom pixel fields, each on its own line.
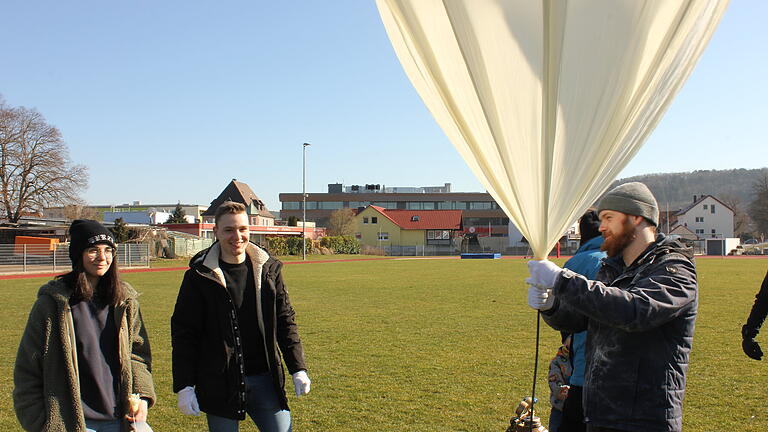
left=542, top=234, right=698, bottom=432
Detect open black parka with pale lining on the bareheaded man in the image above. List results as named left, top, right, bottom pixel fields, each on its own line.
left=171, top=243, right=306, bottom=420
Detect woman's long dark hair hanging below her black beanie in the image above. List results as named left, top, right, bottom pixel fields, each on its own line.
left=58, top=251, right=125, bottom=306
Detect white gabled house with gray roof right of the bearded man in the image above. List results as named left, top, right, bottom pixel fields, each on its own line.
left=670, top=195, right=733, bottom=239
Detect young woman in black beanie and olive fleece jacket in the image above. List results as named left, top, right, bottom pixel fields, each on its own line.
left=13, top=220, right=155, bottom=432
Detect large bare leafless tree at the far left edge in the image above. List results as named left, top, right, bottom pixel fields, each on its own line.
left=0, top=99, right=88, bottom=222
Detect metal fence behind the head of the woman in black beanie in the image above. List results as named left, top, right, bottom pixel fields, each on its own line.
left=0, top=243, right=149, bottom=274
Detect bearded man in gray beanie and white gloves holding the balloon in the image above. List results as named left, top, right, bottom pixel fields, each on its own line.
left=526, top=183, right=698, bottom=432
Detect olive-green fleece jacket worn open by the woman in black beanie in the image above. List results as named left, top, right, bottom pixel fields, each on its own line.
left=13, top=279, right=155, bottom=432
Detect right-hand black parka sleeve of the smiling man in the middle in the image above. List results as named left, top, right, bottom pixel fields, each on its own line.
left=269, top=263, right=307, bottom=374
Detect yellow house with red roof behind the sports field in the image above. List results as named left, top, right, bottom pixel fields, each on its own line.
left=355, top=205, right=463, bottom=249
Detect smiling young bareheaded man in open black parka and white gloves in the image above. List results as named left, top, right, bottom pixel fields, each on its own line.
left=171, top=201, right=310, bottom=432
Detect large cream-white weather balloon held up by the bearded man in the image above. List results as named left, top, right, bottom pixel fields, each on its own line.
left=377, top=0, right=728, bottom=258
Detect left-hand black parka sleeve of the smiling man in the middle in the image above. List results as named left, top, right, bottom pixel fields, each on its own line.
left=171, top=269, right=204, bottom=392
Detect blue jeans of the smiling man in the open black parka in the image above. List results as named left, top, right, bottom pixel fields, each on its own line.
left=206, top=373, right=292, bottom=432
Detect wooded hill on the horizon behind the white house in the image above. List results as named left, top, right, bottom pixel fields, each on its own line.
left=609, top=168, right=768, bottom=211
